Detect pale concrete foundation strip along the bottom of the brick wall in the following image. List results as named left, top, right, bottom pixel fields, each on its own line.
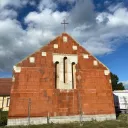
left=7, top=114, right=116, bottom=126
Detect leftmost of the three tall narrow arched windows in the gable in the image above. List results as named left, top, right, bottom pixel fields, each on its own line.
left=55, top=61, right=59, bottom=88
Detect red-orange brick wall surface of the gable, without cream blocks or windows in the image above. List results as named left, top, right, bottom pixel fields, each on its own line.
left=9, top=34, right=114, bottom=118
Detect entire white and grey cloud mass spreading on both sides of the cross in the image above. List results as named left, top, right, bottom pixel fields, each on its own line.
left=0, top=0, right=128, bottom=70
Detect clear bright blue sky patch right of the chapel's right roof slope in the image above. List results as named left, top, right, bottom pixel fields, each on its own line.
left=97, top=39, right=128, bottom=81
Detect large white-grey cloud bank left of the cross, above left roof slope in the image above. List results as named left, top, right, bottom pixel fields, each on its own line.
left=0, top=9, right=67, bottom=70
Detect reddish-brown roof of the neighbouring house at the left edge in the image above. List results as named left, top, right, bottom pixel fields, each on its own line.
left=0, top=78, right=12, bottom=96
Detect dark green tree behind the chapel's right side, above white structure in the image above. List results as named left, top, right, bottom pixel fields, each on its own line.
left=110, top=73, right=125, bottom=91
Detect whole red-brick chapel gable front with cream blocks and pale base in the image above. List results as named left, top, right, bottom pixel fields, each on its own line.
left=8, top=33, right=116, bottom=125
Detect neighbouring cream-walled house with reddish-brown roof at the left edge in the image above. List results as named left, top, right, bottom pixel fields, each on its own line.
left=0, top=78, right=12, bottom=111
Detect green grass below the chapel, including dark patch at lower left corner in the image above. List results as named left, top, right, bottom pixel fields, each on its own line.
left=0, top=112, right=128, bottom=128
